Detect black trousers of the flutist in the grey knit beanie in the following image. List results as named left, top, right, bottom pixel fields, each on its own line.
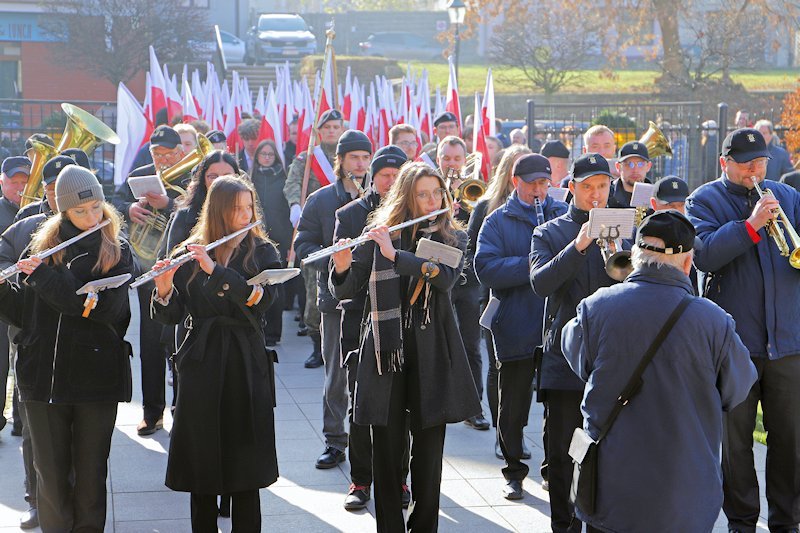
left=24, top=402, right=117, bottom=533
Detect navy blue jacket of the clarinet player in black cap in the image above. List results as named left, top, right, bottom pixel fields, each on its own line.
left=475, top=191, right=567, bottom=362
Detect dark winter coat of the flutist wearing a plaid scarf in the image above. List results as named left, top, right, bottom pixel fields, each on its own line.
left=330, top=227, right=481, bottom=428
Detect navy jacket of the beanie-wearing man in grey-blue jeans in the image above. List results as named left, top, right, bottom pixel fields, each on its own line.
left=294, top=180, right=353, bottom=313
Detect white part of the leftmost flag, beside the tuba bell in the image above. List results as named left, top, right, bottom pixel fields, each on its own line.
left=114, top=82, right=150, bottom=185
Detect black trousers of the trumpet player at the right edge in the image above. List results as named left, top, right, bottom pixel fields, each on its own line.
left=722, top=356, right=800, bottom=532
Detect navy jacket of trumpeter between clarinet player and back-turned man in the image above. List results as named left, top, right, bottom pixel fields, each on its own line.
left=530, top=204, right=617, bottom=390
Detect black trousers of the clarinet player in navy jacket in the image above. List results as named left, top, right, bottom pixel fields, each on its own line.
left=497, top=358, right=535, bottom=481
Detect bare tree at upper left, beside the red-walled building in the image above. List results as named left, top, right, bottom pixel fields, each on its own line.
left=42, top=0, right=212, bottom=85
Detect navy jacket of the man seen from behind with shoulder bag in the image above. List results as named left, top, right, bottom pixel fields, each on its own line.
left=562, top=265, right=756, bottom=532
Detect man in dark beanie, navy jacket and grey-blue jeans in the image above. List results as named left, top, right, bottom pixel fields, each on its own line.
left=294, top=130, right=372, bottom=469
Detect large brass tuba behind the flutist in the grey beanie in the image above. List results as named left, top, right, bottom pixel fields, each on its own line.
left=19, top=103, right=120, bottom=207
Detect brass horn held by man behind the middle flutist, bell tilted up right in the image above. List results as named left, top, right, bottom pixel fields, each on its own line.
left=129, top=134, right=214, bottom=265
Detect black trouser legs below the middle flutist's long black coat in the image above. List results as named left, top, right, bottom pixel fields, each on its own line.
left=191, top=489, right=261, bottom=533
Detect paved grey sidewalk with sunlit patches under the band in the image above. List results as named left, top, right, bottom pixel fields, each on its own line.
left=0, top=299, right=766, bottom=533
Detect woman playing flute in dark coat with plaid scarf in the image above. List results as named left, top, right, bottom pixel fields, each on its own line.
left=330, top=163, right=480, bottom=533
